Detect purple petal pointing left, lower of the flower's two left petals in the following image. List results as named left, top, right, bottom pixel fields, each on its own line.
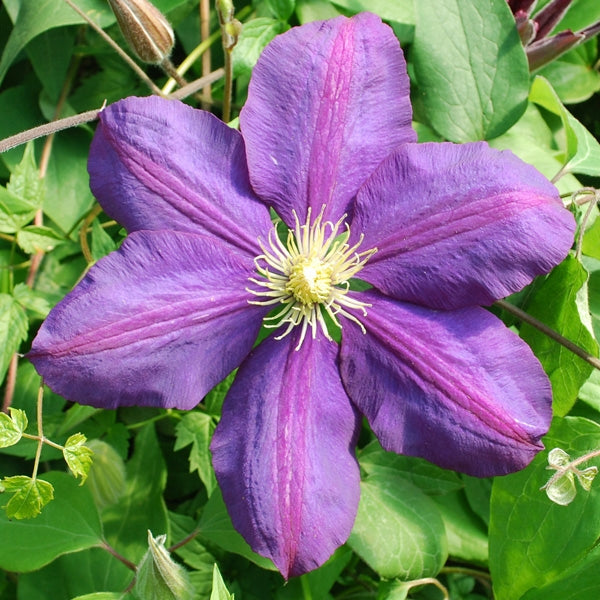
left=28, top=231, right=265, bottom=409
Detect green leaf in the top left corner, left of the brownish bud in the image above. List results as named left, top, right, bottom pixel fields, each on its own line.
left=0, top=0, right=115, bottom=83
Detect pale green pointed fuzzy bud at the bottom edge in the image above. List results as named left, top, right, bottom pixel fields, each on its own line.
left=134, top=531, right=194, bottom=600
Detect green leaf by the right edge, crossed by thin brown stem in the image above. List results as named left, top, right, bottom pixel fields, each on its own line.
left=520, top=256, right=598, bottom=416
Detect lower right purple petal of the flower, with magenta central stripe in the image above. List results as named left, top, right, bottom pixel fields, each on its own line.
left=340, top=292, right=552, bottom=477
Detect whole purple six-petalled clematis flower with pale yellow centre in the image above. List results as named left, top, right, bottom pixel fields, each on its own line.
left=29, top=14, right=574, bottom=578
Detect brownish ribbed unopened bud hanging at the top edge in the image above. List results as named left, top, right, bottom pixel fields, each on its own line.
left=108, top=0, right=175, bottom=63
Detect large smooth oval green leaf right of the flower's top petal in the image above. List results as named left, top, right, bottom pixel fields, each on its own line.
left=412, top=0, right=529, bottom=142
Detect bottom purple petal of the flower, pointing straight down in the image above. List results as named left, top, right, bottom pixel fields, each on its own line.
left=211, top=334, right=360, bottom=579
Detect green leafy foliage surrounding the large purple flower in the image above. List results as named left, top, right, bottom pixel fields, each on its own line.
left=0, top=0, right=600, bottom=600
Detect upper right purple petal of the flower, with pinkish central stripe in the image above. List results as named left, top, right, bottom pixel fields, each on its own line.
left=351, top=143, right=575, bottom=309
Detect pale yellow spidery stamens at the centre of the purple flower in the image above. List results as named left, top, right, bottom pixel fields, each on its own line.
left=248, top=206, right=377, bottom=350
